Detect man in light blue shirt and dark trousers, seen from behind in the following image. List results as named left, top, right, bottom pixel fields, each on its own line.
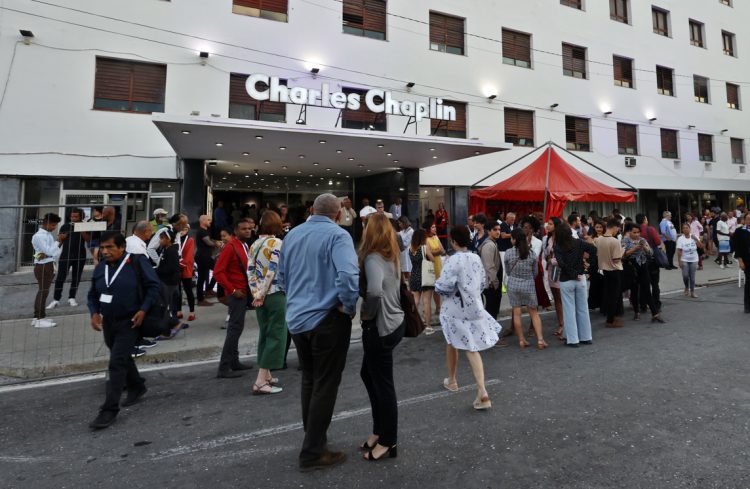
left=279, top=194, right=359, bottom=471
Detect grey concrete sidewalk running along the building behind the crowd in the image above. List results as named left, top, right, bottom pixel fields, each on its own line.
left=0, top=260, right=739, bottom=383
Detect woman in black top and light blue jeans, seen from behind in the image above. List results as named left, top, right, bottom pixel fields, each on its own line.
left=554, top=221, right=596, bottom=348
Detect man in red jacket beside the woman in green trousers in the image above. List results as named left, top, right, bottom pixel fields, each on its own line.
left=214, top=219, right=253, bottom=379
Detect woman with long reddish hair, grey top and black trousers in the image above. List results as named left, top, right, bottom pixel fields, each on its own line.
left=359, top=214, right=405, bottom=461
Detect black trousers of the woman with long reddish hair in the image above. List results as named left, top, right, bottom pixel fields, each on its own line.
left=359, top=322, right=406, bottom=447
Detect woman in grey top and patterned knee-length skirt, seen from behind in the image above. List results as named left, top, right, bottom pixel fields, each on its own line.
left=503, top=228, right=547, bottom=350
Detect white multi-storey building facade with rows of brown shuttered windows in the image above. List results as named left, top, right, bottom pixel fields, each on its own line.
left=0, top=0, right=750, bottom=265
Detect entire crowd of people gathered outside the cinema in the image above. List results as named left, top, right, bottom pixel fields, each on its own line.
left=32, top=194, right=750, bottom=470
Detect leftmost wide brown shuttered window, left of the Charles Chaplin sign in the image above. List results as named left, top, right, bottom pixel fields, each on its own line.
left=94, top=58, right=167, bottom=114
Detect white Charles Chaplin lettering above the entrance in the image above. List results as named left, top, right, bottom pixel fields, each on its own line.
left=245, top=74, right=456, bottom=121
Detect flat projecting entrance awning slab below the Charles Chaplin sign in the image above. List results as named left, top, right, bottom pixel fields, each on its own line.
left=153, top=114, right=511, bottom=189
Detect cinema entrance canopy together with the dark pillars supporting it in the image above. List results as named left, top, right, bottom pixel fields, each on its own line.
left=153, top=114, right=510, bottom=219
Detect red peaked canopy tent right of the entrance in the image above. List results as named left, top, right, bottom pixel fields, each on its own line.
left=469, top=144, right=635, bottom=220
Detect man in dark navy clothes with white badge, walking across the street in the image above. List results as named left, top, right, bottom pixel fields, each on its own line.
left=88, top=231, right=159, bottom=429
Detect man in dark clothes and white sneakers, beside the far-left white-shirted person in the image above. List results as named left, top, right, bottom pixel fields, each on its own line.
left=47, top=209, right=86, bottom=310
